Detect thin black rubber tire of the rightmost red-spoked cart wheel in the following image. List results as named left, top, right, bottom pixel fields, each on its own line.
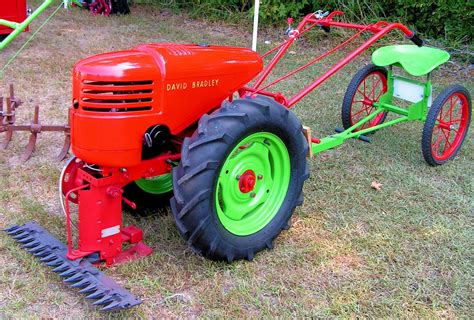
left=421, top=85, right=472, bottom=166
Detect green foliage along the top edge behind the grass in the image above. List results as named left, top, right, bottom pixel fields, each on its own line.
left=143, top=0, right=474, bottom=44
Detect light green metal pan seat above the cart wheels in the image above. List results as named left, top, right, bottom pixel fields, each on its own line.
left=372, top=45, right=449, bottom=77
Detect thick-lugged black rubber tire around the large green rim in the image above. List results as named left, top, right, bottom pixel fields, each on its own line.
left=171, top=96, right=309, bottom=262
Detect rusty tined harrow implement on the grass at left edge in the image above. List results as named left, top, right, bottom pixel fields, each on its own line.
left=0, top=84, right=71, bottom=161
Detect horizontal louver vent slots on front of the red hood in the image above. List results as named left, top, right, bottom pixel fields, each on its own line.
left=79, top=80, right=153, bottom=112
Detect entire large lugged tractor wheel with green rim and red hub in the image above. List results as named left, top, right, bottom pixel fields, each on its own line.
left=171, top=96, right=309, bottom=262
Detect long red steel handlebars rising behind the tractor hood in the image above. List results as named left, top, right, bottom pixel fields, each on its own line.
left=239, top=11, right=415, bottom=108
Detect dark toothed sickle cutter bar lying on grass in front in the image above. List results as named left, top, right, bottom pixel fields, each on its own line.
left=4, top=221, right=141, bottom=311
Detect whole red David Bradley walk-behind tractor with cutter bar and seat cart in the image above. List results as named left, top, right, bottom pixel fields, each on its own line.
left=3, top=12, right=471, bottom=310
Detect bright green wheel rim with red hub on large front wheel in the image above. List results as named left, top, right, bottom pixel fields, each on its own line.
left=215, top=132, right=291, bottom=236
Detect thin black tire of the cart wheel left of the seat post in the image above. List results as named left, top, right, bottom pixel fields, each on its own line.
left=341, top=64, right=388, bottom=131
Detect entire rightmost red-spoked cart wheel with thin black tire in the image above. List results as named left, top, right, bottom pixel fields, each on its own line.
left=421, top=85, right=472, bottom=166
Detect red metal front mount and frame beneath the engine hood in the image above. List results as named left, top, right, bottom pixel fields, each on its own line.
left=65, top=154, right=181, bottom=266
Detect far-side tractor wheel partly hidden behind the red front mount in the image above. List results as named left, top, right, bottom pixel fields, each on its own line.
left=123, top=173, right=173, bottom=216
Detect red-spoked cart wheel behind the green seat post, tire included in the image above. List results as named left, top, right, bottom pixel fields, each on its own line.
left=341, top=64, right=388, bottom=131
